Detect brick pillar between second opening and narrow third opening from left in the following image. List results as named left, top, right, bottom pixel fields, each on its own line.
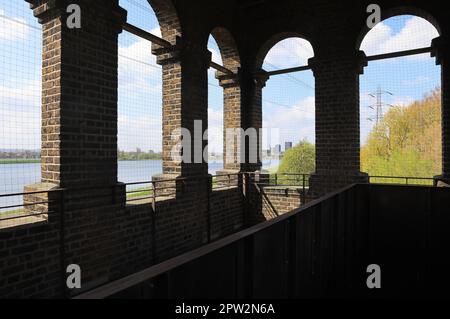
left=152, top=37, right=211, bottom=192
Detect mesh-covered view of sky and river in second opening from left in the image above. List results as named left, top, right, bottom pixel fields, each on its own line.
left=118, top=0, right=162, bottom=189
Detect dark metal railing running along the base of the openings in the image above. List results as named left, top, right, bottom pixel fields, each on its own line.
left=0, top=172, right=435, bottom=226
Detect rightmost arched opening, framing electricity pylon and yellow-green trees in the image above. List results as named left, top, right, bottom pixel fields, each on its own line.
left=360, top=15, right=442, bottom=184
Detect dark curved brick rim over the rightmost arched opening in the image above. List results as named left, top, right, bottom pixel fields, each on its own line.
left=355, top=6, right=442, bottom=50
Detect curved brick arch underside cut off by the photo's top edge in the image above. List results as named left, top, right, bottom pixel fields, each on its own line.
left=147, top=0, right=182, bottom=44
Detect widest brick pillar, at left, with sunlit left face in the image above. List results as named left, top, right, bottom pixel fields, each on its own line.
left=27, top=0, right=126, bottom=204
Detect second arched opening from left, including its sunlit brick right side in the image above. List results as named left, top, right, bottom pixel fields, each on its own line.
left=118, top=0, right=181, bottom=199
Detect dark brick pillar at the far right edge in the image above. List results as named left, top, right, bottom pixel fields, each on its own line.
left=432, top=36, right=450, bottom=184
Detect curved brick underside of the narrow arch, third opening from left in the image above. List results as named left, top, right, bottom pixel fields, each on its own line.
left=211, top=27, right=241, bottom=72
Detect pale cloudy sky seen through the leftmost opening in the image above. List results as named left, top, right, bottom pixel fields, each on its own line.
left=0, top=0, right=42, bottom=149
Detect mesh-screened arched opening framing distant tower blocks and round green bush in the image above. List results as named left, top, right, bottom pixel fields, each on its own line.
left=262, top=38, right=315, bottom=178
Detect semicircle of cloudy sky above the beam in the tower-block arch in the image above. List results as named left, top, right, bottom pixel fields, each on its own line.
left=263, top=38, right=314, bottom=70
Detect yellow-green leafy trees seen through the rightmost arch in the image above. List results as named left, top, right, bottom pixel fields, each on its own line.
left=361, top=88, right=442, bottom=177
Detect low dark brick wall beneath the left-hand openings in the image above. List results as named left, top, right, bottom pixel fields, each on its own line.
left=0, top=181, right=244, bottom=298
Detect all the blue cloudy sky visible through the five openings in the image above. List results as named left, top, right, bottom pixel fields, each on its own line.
left=0, top=0, right=440, bottom=159
